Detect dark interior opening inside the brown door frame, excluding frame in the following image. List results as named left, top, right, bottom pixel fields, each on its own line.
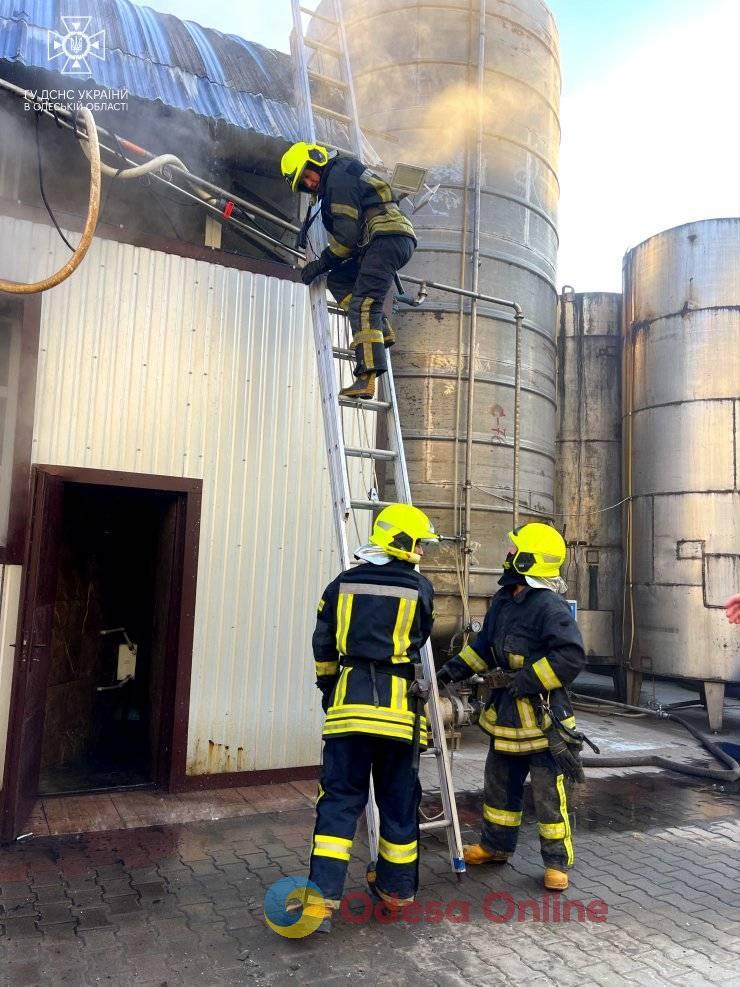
left=39, top=483, right=177, bottom=795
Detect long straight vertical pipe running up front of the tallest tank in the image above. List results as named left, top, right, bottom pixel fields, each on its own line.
left=463, top=0, right=486, bottom=597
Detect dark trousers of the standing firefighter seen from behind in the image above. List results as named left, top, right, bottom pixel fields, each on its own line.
left=310, top=734, right=421, bottom=908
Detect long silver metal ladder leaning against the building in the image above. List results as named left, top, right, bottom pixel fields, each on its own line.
left=291, top=0, right=465, bottom=873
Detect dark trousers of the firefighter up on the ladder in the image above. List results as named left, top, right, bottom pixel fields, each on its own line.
left=326, top=233, right=415, bottom=377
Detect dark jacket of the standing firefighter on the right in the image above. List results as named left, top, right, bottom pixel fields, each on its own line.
left=440, top=586, right=586, bottom=754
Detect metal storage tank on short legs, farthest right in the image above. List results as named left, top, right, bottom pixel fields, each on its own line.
left=623, top=218, right=740, bottom=729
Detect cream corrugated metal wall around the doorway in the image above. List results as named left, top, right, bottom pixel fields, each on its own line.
left=0, top=218, right=337, bottom=774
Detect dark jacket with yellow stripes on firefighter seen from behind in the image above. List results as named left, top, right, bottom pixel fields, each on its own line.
left=313, top=559, right=434, bottom=745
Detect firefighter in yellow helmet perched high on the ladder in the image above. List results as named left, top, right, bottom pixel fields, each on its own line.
left=281, top=142, right=416, bottom=399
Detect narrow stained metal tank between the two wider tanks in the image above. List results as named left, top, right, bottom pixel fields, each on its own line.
left=556, top=289, right=624, bottom=693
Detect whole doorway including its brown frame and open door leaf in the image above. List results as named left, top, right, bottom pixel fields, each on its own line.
left=3, top=467, right=201, bottom=838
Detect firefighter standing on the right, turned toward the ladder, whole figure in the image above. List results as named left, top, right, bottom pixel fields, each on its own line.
left=437, top=523, right=585, bottom=891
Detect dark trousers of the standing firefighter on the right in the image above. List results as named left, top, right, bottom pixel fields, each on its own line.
left=481, top=741, right=573, bottom=870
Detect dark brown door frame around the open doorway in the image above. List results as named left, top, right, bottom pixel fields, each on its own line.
left=0, top=464, right=203, bottom=839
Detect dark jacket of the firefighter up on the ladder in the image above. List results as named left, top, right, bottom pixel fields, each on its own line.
left=317, top=155, right=416, bottom=269
